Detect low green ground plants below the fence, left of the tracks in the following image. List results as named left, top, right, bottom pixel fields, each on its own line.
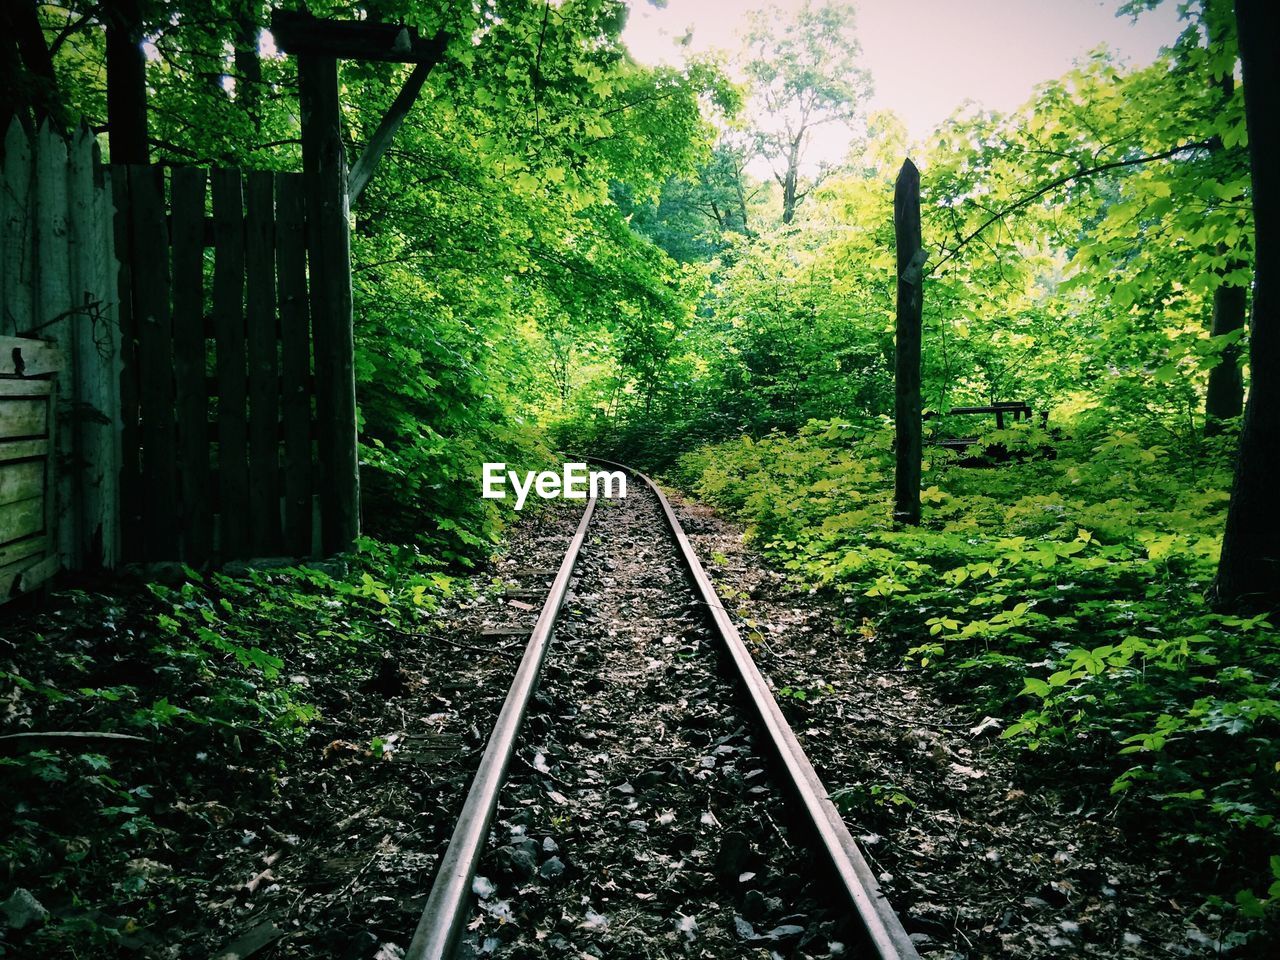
left=0, top=540, right=457, bottom=955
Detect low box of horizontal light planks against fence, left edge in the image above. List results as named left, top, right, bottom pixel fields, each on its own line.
left=0, top=337, right=63, bottom=603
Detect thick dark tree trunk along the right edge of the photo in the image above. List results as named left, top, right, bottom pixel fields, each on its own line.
left=1215, top=0, right=1280, bottom=608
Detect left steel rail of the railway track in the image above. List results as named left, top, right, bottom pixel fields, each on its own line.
left=404, top=498, right=595, bottom=960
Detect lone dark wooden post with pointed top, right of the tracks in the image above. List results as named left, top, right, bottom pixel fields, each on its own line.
left=893, top=160, right=924, bottom=525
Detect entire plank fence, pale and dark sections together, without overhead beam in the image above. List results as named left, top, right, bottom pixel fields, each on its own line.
left=0, top=115, right=358, bottom=578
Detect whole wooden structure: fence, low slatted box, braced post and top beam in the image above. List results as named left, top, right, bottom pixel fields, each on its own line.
left=0, top=12, right=445, bottom=599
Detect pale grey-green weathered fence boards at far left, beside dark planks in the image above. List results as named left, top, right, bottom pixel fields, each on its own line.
left=0, top=120, right=120, bottom=583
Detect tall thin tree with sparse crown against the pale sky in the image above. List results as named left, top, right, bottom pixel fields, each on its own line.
left=746, top=0, right=872, bottom=224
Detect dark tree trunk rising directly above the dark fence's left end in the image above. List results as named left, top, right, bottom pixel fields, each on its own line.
left=104, top=0, right=151, bottom=164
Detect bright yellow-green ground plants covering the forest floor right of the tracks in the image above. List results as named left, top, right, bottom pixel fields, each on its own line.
left=675, top=421, right=1280, bottom=911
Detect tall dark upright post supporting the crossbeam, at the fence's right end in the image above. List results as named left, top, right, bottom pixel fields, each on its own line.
left=298, top=52, right=360, bottom=553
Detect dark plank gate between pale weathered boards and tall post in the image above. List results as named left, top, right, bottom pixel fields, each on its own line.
left=111, top=166, right=340, bottom=563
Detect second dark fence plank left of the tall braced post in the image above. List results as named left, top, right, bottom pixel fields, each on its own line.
left=244, top=170, right=282, bottom=556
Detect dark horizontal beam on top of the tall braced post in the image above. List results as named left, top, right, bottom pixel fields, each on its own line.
left=271, top=10, right=448, bottom=64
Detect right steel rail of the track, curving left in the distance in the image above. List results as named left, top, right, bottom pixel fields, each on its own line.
left=590, top=457, right=920, bottom=960
